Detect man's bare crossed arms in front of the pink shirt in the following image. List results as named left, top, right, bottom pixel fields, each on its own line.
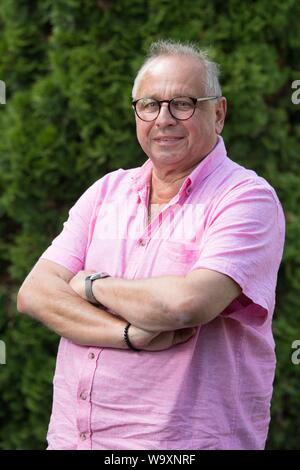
left=17, top=259, right=241, bottom=351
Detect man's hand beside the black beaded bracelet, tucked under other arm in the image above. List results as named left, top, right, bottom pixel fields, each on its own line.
left=128, top=325, right=197, bottom=351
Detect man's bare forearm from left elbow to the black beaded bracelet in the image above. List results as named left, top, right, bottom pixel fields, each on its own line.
left=18, top=277, right=126, bottom=349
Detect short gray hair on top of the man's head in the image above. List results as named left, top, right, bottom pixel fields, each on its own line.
left=132, top=39, right=222, bottom=99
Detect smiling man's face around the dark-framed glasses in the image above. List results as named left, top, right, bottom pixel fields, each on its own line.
left=135, top=57, right=226, bottom=172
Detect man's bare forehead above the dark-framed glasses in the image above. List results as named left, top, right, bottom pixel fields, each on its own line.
left=137, top=57, right=204, bottom=99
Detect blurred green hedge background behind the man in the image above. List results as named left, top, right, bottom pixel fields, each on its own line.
left=0, top=0, right=300, bottom=449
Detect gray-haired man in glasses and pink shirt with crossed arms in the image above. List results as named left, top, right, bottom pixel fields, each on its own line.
left=18, top=41, right=284, bottom=450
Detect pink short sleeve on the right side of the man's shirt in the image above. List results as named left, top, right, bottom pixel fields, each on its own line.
left=192, top=183, right=285, bottom=311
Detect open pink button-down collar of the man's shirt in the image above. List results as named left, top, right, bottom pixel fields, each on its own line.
left=131, top=136, right=227, bottom=196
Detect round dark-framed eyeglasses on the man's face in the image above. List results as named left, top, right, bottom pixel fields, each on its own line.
left=132, top=96, right=220, bottom=122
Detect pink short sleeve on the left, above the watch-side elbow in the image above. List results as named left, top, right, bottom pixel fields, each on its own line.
left=41, top=180, right=100, bottom=273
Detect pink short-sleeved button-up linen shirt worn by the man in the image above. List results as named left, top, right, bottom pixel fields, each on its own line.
left=42, top=138, right=284, bottom=450
